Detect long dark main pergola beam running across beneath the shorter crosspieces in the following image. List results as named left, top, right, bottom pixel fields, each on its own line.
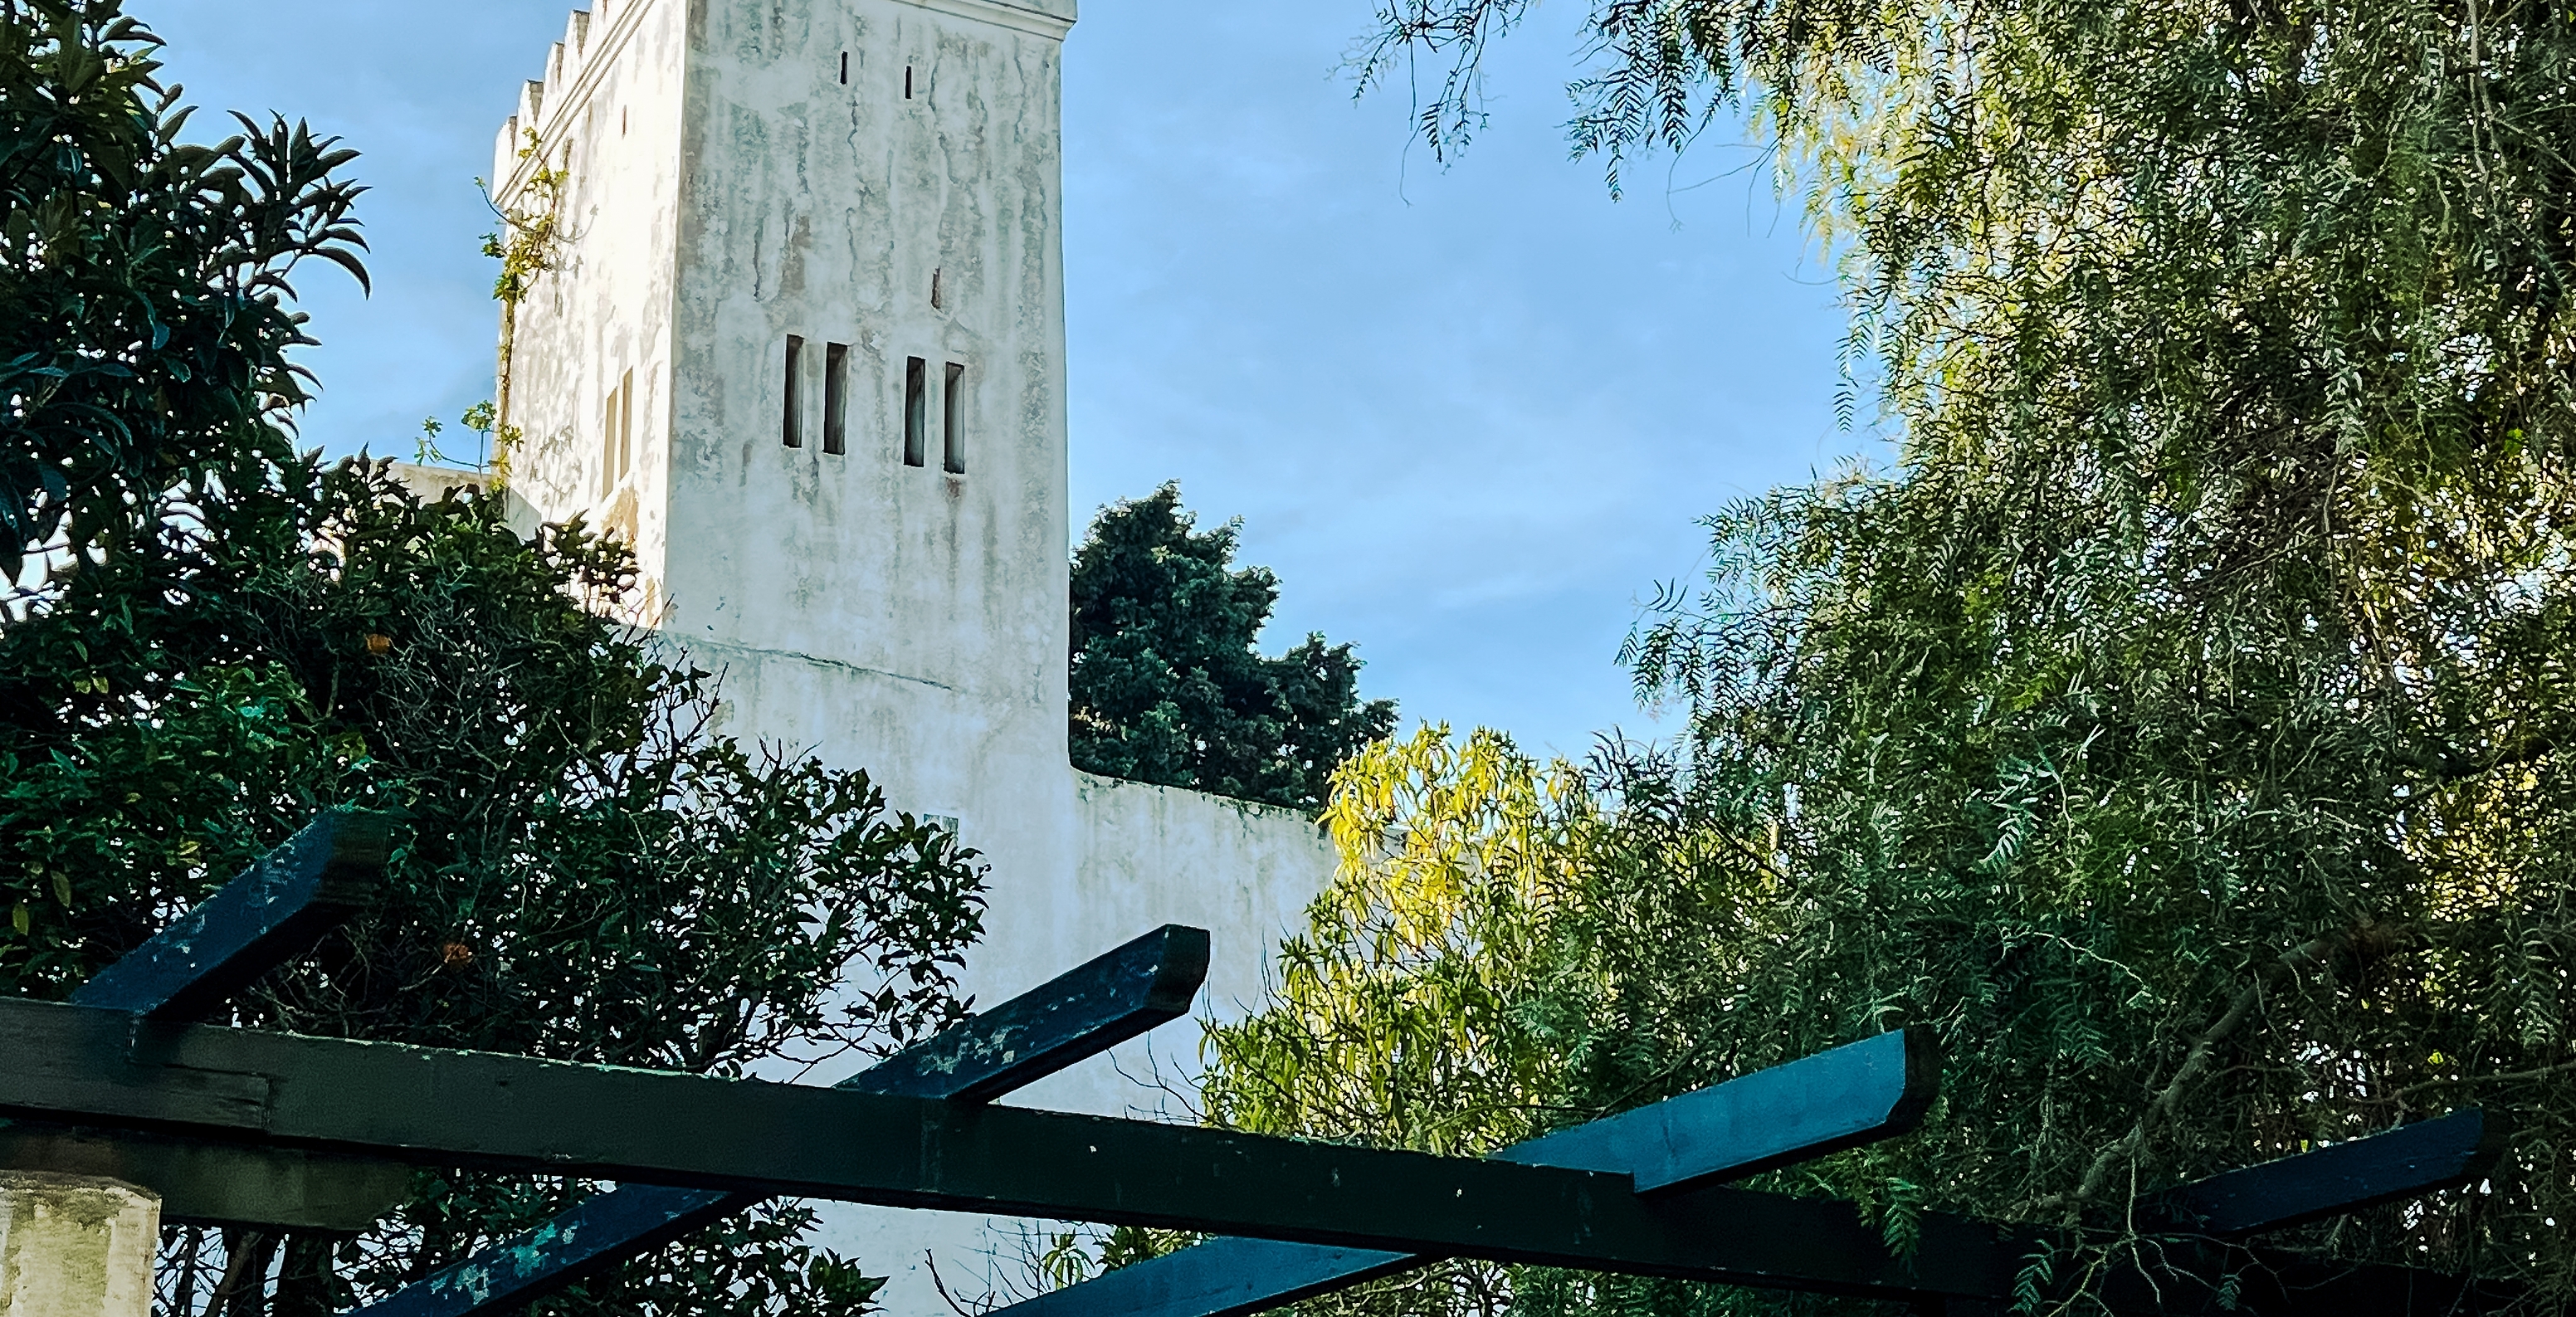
left=0, top=1000, right=2535, bottom=1317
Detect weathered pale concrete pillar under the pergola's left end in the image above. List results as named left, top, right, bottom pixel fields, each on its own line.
left=0, top=1170, right=159, bottom=1317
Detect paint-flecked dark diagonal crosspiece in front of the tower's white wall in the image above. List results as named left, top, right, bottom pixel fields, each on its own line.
left=358, top=925, right=1208, bottom=1317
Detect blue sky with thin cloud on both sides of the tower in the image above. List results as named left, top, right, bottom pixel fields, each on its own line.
left=129, top=0, right=1862, bottom=755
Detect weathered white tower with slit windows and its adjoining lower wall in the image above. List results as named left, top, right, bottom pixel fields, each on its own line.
left=495, top=0, right=1329, bottom=1317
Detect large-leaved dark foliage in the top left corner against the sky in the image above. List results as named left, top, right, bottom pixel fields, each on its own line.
left=0, top=0, right=366, bottom=580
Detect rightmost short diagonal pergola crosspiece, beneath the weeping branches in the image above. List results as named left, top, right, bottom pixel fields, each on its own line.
left=2135, top=1105, right=2509, bottom=1240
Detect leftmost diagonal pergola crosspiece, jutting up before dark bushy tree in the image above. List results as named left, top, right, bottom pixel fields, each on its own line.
left=72, top=809, right=392, bottom=1021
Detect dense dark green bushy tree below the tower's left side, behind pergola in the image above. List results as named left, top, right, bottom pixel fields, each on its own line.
left=0, top=466, right=979, bottom=1312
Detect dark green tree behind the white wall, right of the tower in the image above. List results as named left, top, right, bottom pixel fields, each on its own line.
left=1071, top=485, right=1396, bottom=812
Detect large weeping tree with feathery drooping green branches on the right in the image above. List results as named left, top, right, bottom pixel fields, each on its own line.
left=1211, top=0, right=2576, bottom=1312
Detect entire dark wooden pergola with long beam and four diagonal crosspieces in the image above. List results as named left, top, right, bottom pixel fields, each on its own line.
left=0, top=812, right=2511, bottom=1317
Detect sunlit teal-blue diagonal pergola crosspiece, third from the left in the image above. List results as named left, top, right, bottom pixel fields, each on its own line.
left=992, top=1028, right=1939, bottom=1317
